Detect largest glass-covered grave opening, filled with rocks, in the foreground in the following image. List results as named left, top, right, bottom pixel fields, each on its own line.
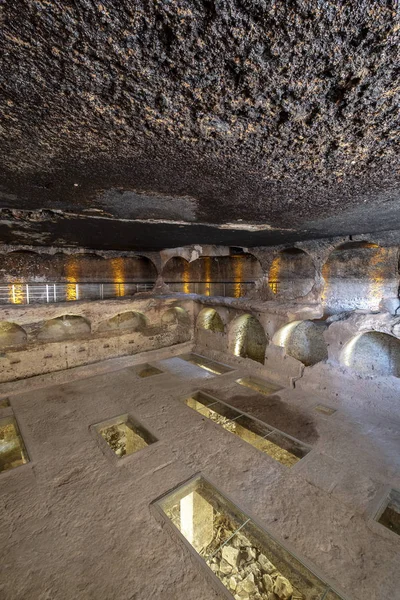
left=155, top=476, right=343, bottom=600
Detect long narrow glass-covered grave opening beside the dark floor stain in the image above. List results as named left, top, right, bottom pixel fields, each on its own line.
left=185, top=391, right=310, bottom=467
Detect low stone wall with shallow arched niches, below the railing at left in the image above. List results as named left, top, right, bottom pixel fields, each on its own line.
left=0, top=298, right=193, bottom=382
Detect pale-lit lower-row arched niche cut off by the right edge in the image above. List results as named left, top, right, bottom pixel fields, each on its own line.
left=340, top=331, right=400, bottom=377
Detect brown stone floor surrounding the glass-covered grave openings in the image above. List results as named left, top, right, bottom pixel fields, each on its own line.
left=0, top=345, right=400, bottom=600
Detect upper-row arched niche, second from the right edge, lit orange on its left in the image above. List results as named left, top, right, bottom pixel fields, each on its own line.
left=268, top=248, right=315, bottom=299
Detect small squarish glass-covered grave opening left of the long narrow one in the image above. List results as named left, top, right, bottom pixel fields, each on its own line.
left=94, top=415, right=157, bottom=458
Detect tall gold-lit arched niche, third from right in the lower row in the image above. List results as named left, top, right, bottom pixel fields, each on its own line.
left=229, top=314, right=268, bottom=364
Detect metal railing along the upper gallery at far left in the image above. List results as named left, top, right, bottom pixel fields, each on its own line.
left=0, top=281, right=154, bottom=304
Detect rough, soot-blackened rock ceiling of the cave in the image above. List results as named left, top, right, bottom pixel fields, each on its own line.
left=0, top=0, right=400, bottom=249
